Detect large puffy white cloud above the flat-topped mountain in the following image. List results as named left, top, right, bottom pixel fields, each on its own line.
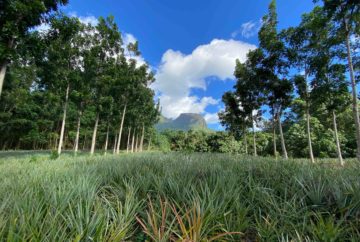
left=152, top=39, right=256, bottom=121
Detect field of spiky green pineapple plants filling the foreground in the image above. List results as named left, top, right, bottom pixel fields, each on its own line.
left=0, top=153, right=360, bottom=241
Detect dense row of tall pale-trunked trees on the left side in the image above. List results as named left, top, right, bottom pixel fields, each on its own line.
left=0, top=6, right=158, bottom=154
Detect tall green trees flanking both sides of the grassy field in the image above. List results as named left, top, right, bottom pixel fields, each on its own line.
left=0, top=1, right=360, bottom=163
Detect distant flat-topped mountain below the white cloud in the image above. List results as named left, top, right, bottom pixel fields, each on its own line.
left=155, top=113, right=207, bottom=131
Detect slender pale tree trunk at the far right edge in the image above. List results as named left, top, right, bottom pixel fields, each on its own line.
left=346, top=31, right=360, bottom=161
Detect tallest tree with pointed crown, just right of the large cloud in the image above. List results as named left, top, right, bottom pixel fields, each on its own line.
left=258, top=0, right=293, bottom=159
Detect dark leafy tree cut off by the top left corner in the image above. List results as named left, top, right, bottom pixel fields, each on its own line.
left=0, top=0, right=68, bottom=96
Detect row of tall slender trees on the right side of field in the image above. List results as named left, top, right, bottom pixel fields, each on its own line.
left=219, top=0, right=360, bottom=165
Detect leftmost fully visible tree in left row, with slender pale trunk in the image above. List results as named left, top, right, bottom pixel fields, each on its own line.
left=39, top=14, right=83, bottom=155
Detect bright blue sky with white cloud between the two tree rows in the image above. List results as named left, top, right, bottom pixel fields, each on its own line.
left=64, top=0, right=314, bottom=129
